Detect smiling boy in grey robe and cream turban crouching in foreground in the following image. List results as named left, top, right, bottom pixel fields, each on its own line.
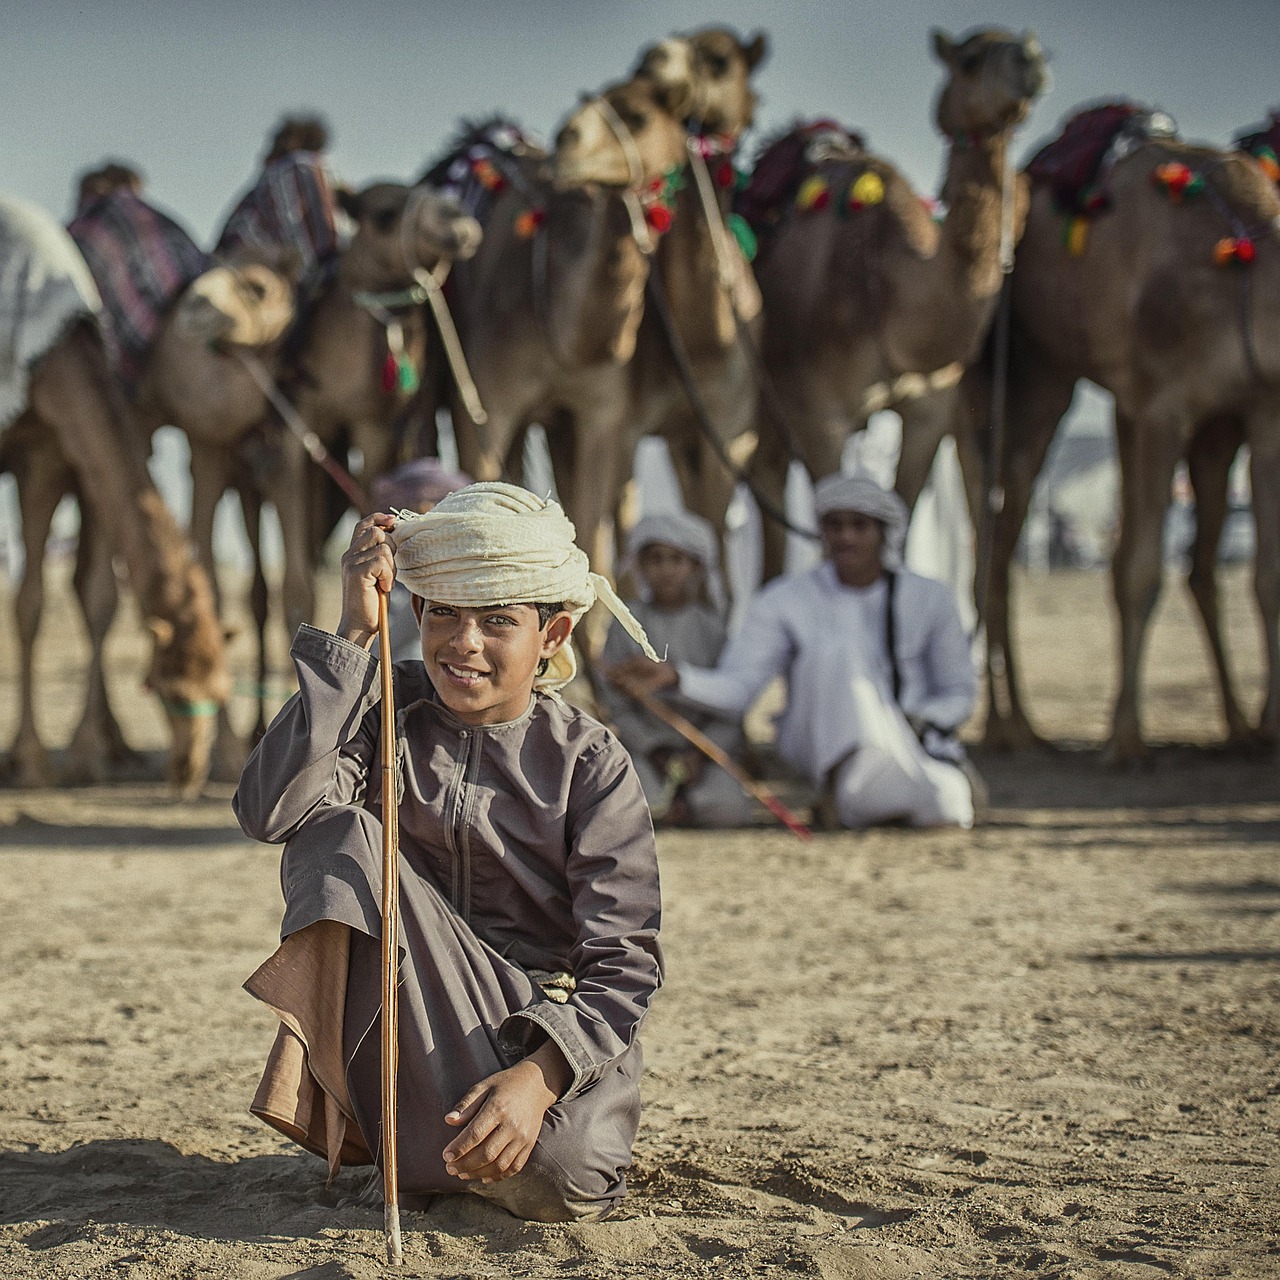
left=234, top=484, right=662, bottom=1221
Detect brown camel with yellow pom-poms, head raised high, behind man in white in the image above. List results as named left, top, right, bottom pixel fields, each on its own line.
left=753, top=31, right=1046, bottom=576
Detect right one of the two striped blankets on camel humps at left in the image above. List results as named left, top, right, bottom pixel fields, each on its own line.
left=215, top=151, right=338, bottom=293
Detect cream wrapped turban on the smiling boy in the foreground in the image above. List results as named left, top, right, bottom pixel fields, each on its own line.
left=388, top=483, right=659, bottom=692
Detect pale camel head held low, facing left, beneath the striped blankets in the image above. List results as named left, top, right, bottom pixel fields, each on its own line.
left=175, top=248, right=298, bottom=347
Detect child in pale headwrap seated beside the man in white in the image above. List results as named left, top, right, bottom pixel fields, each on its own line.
left=602, top=511, right=753, bottom=827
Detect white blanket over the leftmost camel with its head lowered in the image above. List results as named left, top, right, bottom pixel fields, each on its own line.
left=0, top=197, right=101, bottom=431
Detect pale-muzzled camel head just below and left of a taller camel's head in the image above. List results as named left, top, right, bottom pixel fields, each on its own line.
left=554, top=78, right=686, bottom=188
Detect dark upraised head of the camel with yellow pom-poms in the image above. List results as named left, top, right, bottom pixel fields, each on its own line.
left=933, top=29, right=1048, bottom=138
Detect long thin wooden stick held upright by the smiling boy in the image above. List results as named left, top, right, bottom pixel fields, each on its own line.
left=378, top=591, right=404, bottom=1267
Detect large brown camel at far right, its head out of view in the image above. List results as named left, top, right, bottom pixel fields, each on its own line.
left=959, top=117, right=1280, bottom=762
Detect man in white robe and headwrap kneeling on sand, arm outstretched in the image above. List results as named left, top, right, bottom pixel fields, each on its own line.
left=614, top=475, right=975, bottom=827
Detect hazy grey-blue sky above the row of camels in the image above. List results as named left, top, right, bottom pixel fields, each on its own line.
left=0, top=0, right=1280, bottom=565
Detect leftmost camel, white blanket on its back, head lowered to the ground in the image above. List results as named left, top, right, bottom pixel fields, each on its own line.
left=0, top=192, right=230, bottom=795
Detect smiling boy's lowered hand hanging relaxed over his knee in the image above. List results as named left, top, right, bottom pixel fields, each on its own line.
left=442, top=1039, right=573, bottom=1183
